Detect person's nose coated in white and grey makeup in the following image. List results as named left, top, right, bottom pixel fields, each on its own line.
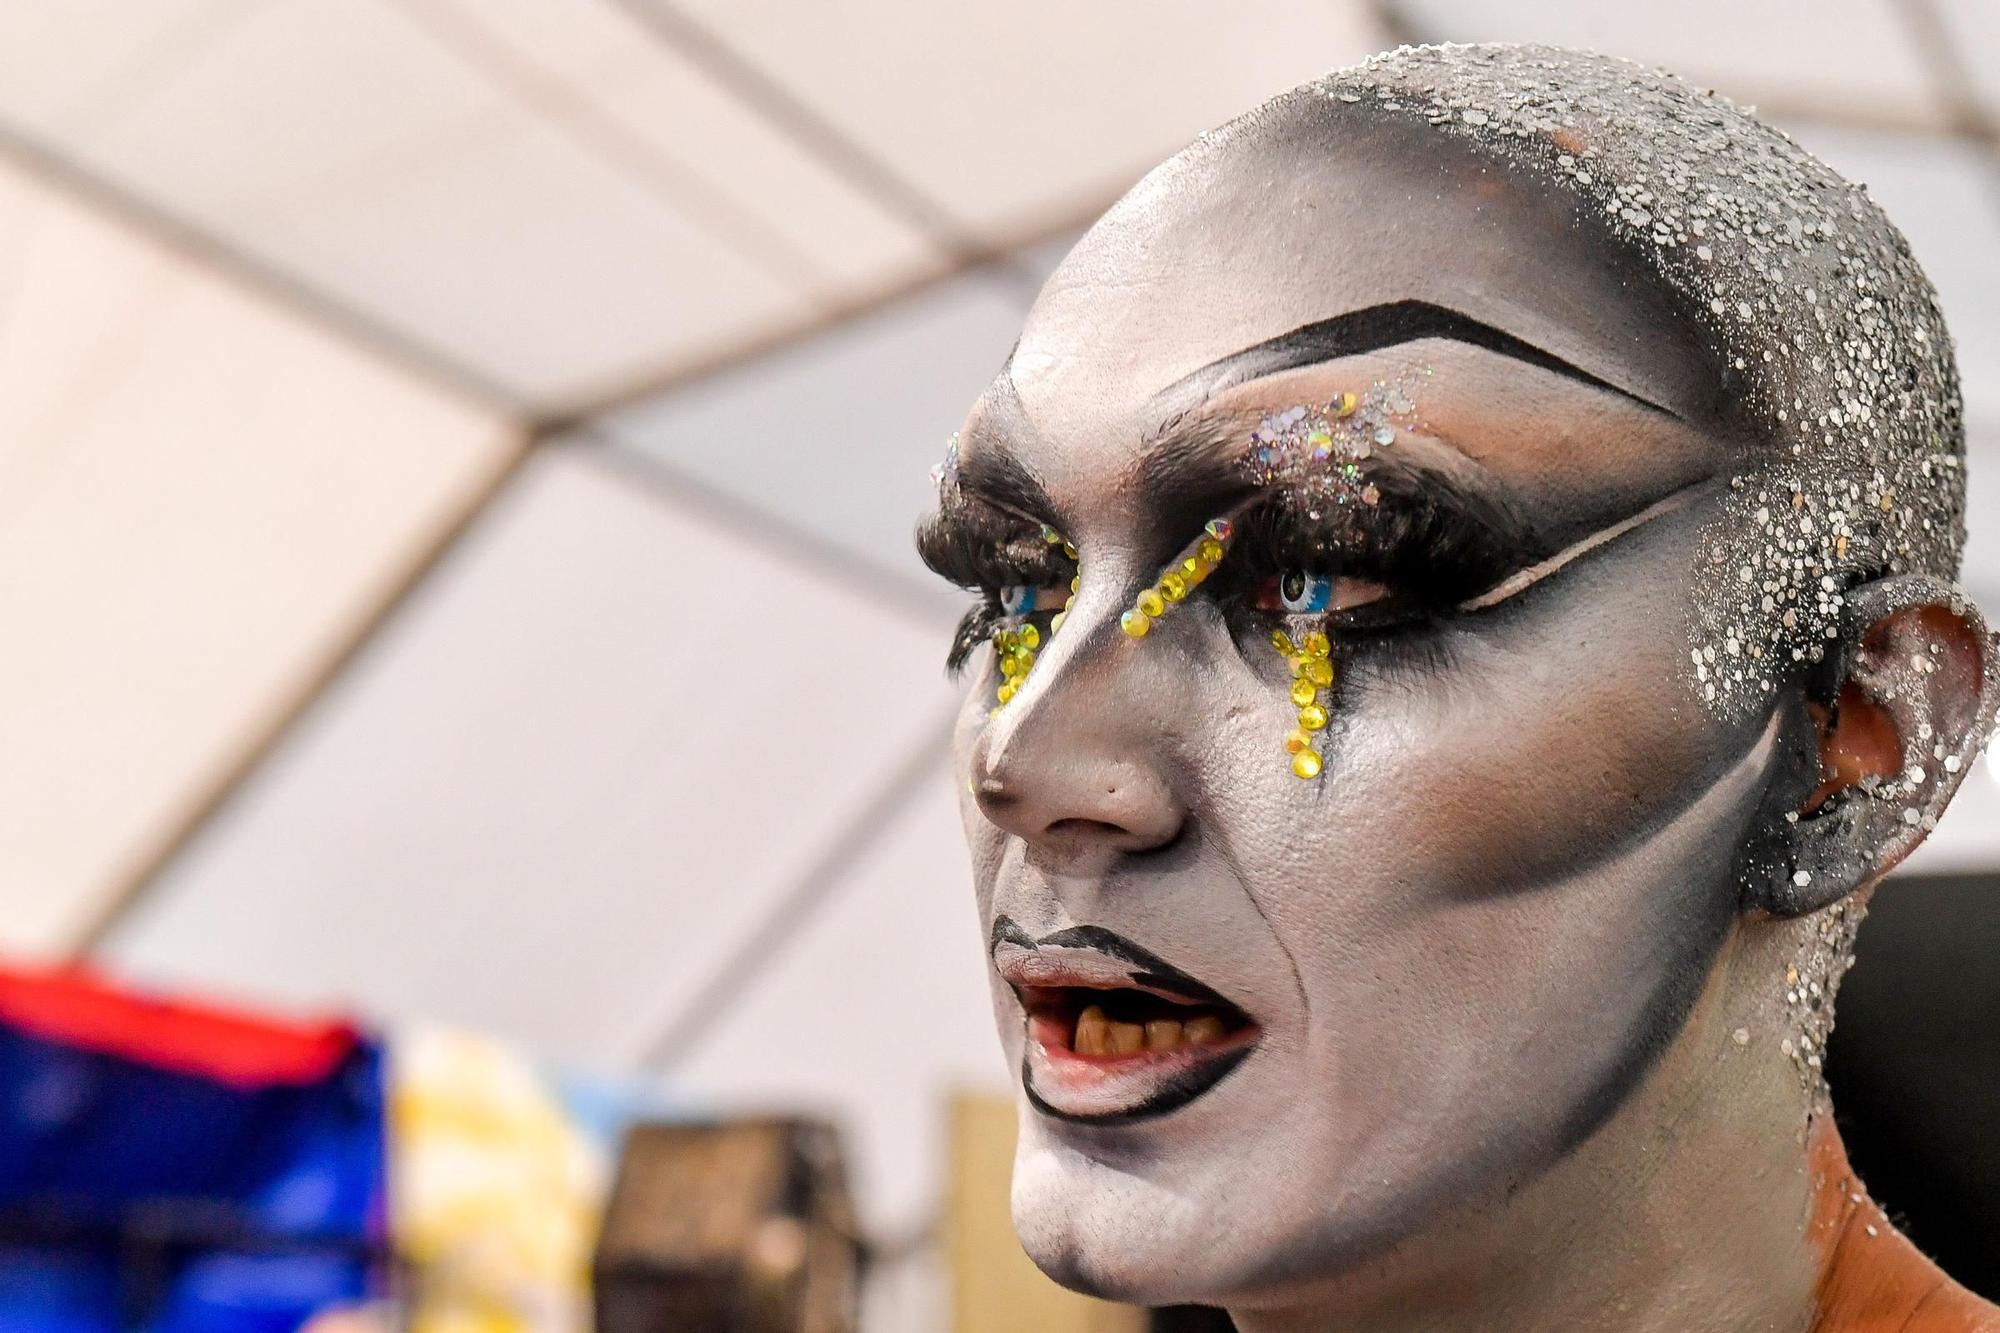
left=970, top=624, right=1188, bottom=857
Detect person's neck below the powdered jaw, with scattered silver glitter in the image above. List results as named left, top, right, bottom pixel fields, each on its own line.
left=1230, top=923, right=1840, bottom=1333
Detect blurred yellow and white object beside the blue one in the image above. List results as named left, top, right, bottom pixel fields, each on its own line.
left=390, top=1031, right=608, bottom=1333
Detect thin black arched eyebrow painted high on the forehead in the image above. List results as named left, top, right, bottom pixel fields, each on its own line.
left=1154, top=300, right=1678, bottom=418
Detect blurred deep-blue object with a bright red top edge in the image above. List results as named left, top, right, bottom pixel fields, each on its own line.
left=0, top=971, right=388, bottom=1333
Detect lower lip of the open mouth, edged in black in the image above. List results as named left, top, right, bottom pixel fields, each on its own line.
left=1020, top=1017, right=1260, bottom=1125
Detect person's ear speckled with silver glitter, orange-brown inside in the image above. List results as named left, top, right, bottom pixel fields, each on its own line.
left=1746, top=574, right=2000, bottom=917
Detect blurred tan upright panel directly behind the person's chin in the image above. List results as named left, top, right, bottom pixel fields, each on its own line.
left=944, top=1093, right=1146, bottom=1333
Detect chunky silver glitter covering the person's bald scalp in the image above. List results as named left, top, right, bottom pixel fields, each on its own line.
left=1314, top=46, right=1964, bottom=717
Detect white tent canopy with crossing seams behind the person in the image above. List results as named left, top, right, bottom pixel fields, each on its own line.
left=0, top=0, right=2000, bottom=1221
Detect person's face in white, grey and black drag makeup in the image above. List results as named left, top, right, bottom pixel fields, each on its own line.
left=940, top=108, right=1772, bottom=1301
